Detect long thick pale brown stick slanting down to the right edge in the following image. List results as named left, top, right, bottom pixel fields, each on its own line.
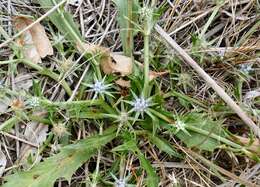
left=155, top=25, right=260, bottom=139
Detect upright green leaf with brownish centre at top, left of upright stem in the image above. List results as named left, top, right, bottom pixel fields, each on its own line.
left=113, top=0, right=139, bottom=56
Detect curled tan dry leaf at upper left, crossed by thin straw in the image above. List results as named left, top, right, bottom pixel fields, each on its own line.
left=14, top=16, right=53, bottom=63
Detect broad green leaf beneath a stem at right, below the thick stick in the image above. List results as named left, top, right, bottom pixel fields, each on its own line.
left=176, top=113, right=225, bottom=151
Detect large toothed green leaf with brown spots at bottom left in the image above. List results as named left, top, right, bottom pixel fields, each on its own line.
left=3, top=128, right=116, bottom=187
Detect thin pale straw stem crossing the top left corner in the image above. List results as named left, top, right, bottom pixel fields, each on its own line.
left=0, top=0, right=68, bottom=48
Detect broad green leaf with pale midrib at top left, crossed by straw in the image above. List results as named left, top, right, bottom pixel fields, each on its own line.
left=38, top=0, right=83, bottom=43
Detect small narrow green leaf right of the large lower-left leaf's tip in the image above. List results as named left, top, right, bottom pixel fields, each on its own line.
left=146, top=132, right=182, bottom=158
